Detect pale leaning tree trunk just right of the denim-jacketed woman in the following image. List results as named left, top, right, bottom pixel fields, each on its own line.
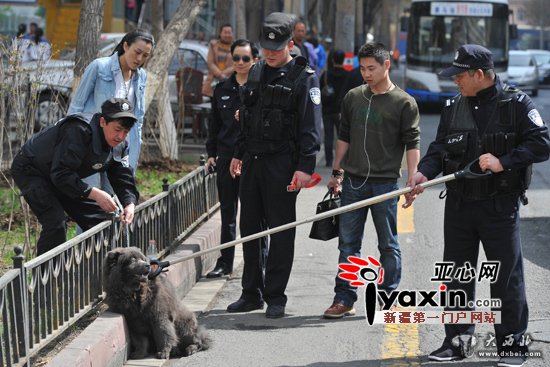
left=145, top=0, right=205, bottom=159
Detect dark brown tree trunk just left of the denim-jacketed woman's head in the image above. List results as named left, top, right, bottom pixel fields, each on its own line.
left=72, top=0, right=105, bottom=93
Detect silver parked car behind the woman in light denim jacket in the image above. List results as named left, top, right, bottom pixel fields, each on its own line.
left=17, top=33, right=208, bottom=128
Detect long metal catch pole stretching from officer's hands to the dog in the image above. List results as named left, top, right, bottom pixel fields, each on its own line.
left=149, top=159, right=492, bottom=278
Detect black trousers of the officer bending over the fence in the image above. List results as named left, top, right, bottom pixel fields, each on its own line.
left=11, top=153, right=111, bottom=255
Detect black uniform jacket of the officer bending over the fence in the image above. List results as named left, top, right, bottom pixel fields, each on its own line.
left=22, top=114, right=139, bottom=206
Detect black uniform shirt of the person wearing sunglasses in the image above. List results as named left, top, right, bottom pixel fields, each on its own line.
left=206, top=74, right=242, bottom=158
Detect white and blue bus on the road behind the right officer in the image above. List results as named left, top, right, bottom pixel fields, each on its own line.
left=404, top=0, right=513, bottom=103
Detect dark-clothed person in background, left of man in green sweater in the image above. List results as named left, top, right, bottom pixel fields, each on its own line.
left=320, top=50, right=349, bottom=167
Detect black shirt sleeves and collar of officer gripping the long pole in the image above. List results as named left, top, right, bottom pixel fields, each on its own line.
left=418, top=77, right=550, bottom=179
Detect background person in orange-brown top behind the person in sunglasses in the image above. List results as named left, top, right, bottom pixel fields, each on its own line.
left=202, top=24, right=233, bottom=97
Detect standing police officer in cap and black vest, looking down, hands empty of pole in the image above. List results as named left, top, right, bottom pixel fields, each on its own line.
left=227, top=13, right=321, bottom=318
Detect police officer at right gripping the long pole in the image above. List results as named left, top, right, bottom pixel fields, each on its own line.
left=405, top=44, right=550, bottom=366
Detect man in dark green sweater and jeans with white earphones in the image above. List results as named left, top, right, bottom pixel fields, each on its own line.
left=324, top=43, right=420, bottom=319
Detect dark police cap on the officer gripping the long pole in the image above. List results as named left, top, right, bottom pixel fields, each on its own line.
left=439, top=44, right=494, bottom=76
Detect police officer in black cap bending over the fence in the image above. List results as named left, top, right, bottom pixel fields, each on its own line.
left=11, top=98, right=139, bottom=255
